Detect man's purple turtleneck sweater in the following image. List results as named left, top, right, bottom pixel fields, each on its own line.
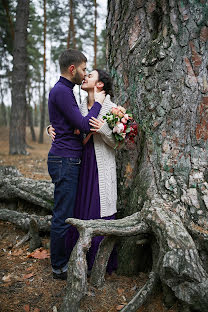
left=48, top=76, right=101, bottom=158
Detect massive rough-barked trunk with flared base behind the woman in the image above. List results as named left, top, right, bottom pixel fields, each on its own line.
left=104, top=0, right=208, bottom=311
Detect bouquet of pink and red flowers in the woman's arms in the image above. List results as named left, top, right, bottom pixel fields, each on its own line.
left=103, top=106, right=138, bottom=148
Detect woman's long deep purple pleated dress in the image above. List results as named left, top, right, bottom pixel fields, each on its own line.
left=66, top=135, right=117, bottom=273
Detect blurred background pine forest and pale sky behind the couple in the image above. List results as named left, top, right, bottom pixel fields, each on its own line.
left=0, top=0, right=106, bottom=146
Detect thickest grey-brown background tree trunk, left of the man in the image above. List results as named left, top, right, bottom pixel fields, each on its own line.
left=9, top=0, right=29, bottom=154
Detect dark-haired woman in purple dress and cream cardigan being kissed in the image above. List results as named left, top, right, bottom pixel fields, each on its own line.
left=48, top=69, right=117, bottom=273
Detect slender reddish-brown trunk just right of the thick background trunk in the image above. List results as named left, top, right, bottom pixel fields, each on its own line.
left=38, top=0, right=46, bottom=143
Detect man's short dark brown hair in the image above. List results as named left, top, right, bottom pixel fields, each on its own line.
left=59, top=49, right=87, bottom=74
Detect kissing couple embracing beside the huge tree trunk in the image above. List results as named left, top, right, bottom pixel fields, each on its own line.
left=48, top=49, right=117, bottom=279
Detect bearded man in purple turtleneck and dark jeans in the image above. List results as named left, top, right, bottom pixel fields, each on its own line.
left=48, top=49, right=105, bottom=279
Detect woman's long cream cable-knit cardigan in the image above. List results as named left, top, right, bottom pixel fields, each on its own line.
left=79, top=95, right=117, bottom=217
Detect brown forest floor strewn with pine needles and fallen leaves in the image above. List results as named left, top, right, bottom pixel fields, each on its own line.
left=0, top=127, right=179, bottom=312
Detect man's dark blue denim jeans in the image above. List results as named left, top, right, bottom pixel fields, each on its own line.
left=48, top=153, right=81, bottom=273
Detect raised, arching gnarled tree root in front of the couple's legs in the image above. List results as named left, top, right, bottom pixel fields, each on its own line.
left=61, top=213, right=150, bottom=312
